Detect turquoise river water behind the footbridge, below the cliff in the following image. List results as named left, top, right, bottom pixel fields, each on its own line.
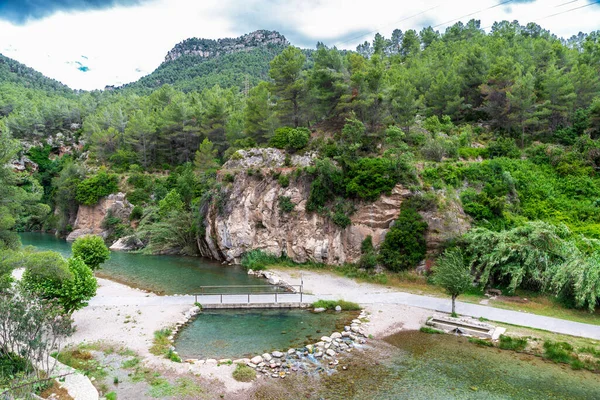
left=20, top=233, right=271, bottom=295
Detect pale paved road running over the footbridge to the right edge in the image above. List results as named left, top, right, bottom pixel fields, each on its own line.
left=90, top=291, right=600, bottom=340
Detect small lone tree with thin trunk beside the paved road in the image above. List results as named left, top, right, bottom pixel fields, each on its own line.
left=433, top=248, right=473, bottom=317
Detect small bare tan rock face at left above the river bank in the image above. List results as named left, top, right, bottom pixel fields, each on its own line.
left=67, top=193, right=133, bottom=242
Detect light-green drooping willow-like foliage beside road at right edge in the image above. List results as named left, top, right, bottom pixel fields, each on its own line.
left=465, top=221, right=600, bottom=311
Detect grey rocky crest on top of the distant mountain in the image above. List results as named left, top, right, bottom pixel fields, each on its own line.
left=165, top=30, right=289, bottom=62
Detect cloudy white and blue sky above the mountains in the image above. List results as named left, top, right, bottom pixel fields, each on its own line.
left=0, top=0, right=600, bottom=90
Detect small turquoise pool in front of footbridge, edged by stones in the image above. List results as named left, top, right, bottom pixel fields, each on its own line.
left=175, top=309, right=357, bottom=359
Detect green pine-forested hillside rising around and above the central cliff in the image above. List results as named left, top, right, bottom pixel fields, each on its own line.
left=0, top=21, right=600, bottom=309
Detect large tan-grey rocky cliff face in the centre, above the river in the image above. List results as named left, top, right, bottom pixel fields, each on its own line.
left=198, top=149, right=469, bottom=264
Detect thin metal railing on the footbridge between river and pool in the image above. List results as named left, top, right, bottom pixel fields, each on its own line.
left=193, top=285, right=304, bottom=304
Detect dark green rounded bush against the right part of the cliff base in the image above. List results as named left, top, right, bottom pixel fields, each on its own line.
left=379, top=208, right=427, bottom=272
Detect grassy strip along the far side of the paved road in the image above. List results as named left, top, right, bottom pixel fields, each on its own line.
left=270, top=260, right=600, bottom=325
